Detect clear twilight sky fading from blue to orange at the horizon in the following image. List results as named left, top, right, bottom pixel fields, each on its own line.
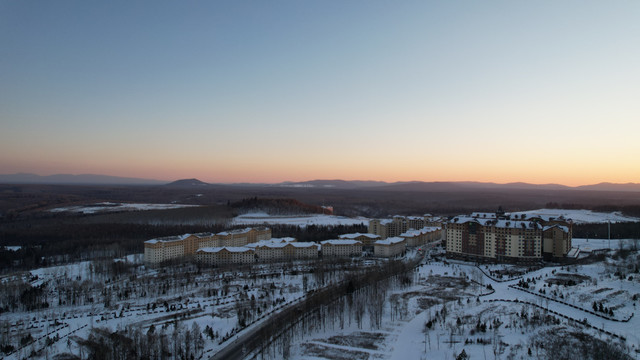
left=0, top=0, right=640, bottom=185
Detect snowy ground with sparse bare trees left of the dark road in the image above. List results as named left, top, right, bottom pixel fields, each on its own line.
left=0, top=254, right=364, bottom=359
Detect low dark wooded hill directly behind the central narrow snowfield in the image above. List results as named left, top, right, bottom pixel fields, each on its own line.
left=230, top=197, right=323, bottom=215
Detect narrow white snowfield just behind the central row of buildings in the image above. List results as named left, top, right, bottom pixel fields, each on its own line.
left=233, top=213, right=369, bottom=227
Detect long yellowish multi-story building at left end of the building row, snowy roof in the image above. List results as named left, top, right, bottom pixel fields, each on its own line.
left=144, top=228, right=271, bottom=264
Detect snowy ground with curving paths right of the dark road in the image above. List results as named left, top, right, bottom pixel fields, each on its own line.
left=288, top=252, right=640, bottom=360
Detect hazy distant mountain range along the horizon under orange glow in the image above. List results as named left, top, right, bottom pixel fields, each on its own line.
left=0, top=174, right=640, bottom=192
